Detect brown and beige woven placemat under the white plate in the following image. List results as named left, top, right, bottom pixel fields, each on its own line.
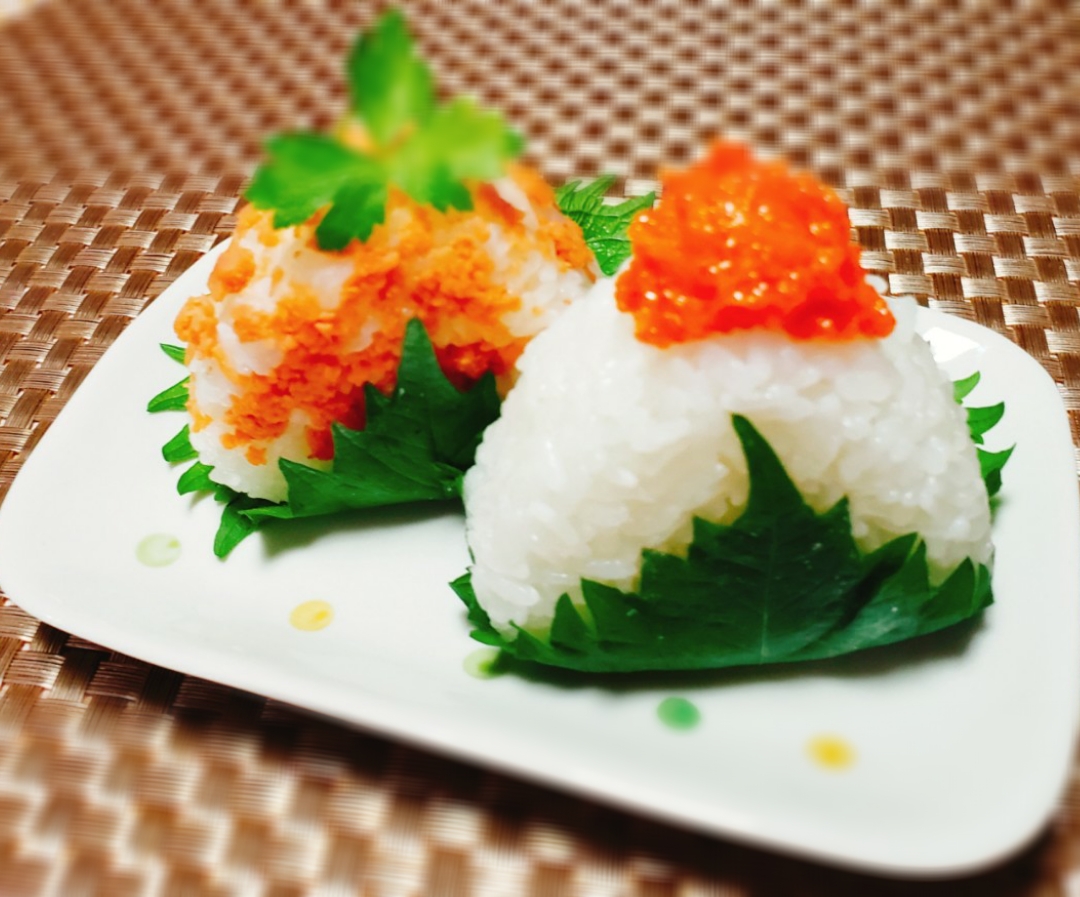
left=0, top=0, right=1080, bottom=897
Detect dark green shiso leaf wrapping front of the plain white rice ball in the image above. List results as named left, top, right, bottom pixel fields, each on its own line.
left=451, top=416, right=993, bottom=672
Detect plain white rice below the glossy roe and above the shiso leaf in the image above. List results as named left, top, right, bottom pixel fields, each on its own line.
left=464, top=280, right=991, bottom=636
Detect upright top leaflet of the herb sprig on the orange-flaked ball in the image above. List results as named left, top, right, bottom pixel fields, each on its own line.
left=348, top=10, right=435, bottom=145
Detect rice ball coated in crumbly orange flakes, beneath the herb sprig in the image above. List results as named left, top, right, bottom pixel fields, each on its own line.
left=176, top=165, right=597, bottom=501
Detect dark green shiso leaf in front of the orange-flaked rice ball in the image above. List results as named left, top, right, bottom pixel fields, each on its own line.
left=152, top=320, right=499, bottom=557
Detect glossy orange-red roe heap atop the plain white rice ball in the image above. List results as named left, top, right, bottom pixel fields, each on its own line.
left=616, top=141, right=895, bottom=346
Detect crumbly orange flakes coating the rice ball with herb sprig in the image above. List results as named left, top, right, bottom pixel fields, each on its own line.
left=176, top=168, right=592, bottom=464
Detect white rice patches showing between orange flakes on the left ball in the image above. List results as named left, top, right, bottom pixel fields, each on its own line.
left=189, top=177, right=594, bottom=502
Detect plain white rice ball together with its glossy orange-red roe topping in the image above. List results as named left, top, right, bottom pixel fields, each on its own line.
left=464, top=142, right=993, bottom=651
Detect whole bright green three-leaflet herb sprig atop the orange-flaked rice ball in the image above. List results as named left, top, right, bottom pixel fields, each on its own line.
left=244, top=10, right=523, bottom=250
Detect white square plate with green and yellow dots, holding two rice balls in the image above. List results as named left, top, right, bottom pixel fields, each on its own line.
left=0, top=240, right=1080, bottom=875
